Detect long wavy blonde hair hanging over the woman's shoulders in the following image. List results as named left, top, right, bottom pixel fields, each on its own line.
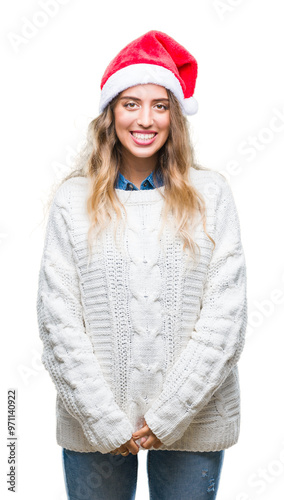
left=45, top=89, right=215, bottom=266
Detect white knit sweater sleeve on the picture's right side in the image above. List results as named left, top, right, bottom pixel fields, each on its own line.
left=144, top=179, right=247, bottom=446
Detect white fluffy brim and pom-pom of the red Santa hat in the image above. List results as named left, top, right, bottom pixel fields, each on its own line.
left=99, top=63, right=198, bottom=115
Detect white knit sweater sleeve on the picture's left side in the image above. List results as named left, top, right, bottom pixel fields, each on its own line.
left=37, top=196, right=134, bottom=453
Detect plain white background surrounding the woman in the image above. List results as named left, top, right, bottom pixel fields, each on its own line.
left=0, top=0, right=284, bottom=500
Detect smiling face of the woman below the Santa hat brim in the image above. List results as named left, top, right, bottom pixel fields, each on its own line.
left=114, top=83, right=170, bottom=159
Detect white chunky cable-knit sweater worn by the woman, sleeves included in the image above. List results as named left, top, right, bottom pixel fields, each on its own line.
left=37, top=169, right=247, bottom=453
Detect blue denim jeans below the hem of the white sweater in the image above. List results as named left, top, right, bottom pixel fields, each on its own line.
left=62, top=448, right=225, bottom=500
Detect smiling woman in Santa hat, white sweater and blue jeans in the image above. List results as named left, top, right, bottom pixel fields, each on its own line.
left=37, top=31, right=247, bottom=500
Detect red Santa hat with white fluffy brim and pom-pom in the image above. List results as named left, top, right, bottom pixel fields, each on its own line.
left=99, top=30, right=198, bottom=115
